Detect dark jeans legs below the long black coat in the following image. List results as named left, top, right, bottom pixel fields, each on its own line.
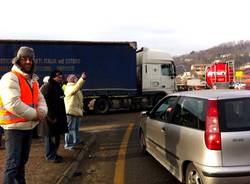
left=44, top=135, right=60, bottom=160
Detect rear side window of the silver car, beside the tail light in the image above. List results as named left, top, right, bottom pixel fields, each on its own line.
left=173, top=97, right=206, bottom=130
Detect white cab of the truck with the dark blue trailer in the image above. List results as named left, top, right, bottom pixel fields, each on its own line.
left=137, top=47, right=176, bottom=98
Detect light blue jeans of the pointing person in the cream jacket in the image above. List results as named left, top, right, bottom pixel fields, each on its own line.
left=64, top=115, right=81, bottom=149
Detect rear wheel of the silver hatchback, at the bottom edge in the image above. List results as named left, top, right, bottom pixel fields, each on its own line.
left=185, top=163, right=203, bottom=184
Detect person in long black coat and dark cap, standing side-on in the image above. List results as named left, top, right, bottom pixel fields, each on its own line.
left=43, top=70, right=68, bottom=163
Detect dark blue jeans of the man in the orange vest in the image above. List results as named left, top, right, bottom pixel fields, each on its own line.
left=3, top=130, right=32, bottom=184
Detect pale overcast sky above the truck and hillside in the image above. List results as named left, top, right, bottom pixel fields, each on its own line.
left=0, top=0, right=250, bottom=56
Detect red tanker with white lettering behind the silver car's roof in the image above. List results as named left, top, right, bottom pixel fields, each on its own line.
left=206, top=60, right=234, bottom=88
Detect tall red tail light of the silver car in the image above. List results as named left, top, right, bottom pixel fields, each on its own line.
left=205, top=100, right=221, bottom=150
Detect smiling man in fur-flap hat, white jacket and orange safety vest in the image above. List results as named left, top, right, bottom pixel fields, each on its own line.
left=0, top=46, right=47, bottom=184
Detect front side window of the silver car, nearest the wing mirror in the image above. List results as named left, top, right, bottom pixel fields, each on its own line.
left=152, top=96, right=178, bottom=122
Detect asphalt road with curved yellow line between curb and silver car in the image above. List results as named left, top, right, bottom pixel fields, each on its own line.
left=72, top=112, right=180, bottom=184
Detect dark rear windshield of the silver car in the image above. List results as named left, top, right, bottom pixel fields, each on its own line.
left=219, top=98, right=250, bottom=132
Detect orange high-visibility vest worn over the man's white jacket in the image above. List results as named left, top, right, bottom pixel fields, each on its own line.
left=0, top=71, right=39, bottom=125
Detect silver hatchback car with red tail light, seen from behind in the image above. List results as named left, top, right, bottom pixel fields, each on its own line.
left=139, top=90, right=250, bottom=184
